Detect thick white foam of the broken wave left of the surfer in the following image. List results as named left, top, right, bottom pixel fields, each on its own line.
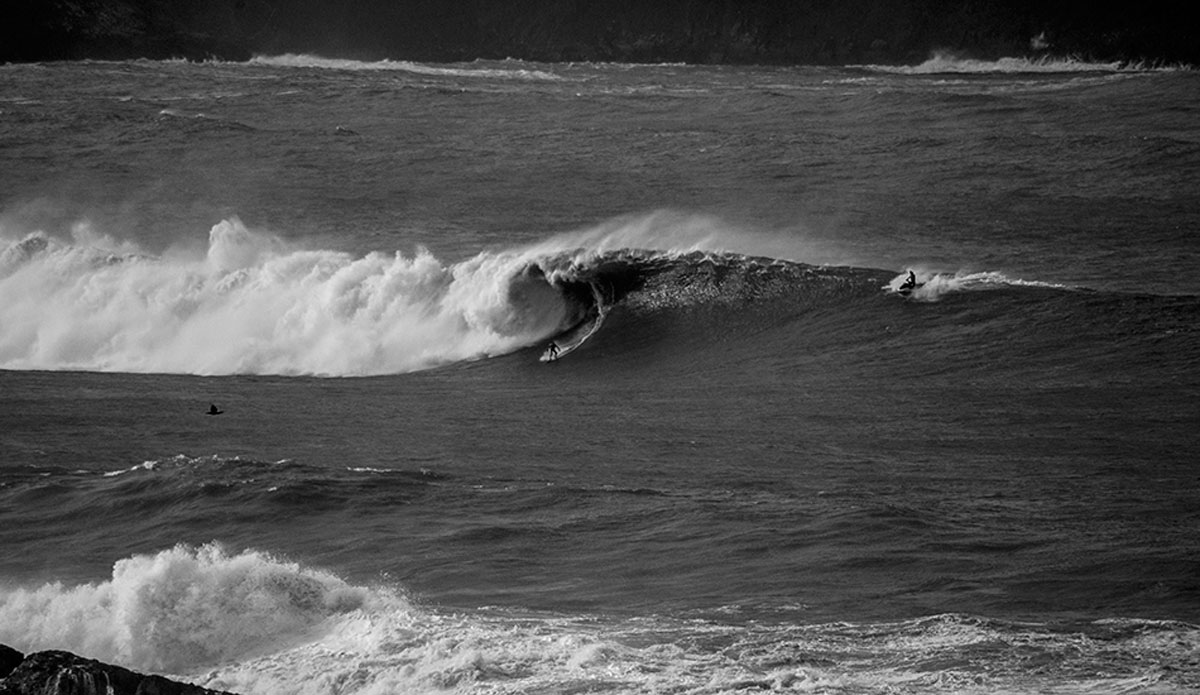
left=0, top=220, right=574, bottom=376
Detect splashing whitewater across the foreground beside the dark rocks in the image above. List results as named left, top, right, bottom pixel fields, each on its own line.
left=0, top=544, right=1200, bottom=695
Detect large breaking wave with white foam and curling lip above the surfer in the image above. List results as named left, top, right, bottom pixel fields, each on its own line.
left=0, top=214, right=888, bottom=376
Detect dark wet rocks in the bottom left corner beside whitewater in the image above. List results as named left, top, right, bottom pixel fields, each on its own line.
left=0, top=645, right=236, bottom=695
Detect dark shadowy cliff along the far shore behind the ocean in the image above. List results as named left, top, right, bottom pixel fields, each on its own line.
left=0, top=0, right=1200, bottom=64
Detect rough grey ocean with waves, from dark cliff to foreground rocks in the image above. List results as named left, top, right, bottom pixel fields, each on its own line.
left=0, top=55, right=1200, bottom=695
